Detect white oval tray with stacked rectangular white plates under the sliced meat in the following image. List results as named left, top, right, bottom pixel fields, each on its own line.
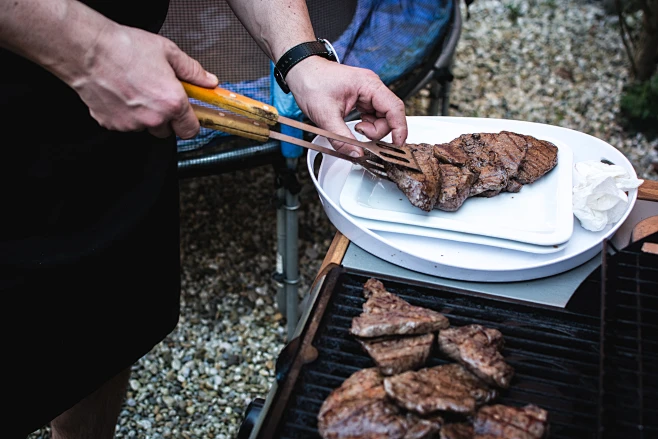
left=308, top=117, right=637, bottom=282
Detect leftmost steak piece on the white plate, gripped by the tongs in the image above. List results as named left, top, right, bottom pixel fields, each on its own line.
left=385, top=143, right=441, bottom=212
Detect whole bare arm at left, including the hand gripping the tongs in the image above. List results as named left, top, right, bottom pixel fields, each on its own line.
left=0, top=0, right=218, bottom=138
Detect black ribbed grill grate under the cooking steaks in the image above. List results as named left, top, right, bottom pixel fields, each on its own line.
left=277, top=269, right=600, bottom=439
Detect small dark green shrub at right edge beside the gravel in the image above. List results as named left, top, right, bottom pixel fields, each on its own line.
left=619, top=74, right=658, bottom=137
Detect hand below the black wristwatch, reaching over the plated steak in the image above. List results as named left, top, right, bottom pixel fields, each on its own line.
left=286, top=56, right=407, bottom=156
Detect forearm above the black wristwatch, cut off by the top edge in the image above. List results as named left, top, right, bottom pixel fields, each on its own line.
left=227, top=0, right=315, bottom=62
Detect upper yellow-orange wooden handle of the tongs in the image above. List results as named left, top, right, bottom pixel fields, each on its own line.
left=181, top=81, right=279, bottom=125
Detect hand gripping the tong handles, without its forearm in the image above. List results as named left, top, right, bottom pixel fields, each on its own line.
left=67, top=23, right=218, bottom=139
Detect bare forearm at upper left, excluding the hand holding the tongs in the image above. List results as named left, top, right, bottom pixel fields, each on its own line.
left=0, top=0, right=113, bottom=85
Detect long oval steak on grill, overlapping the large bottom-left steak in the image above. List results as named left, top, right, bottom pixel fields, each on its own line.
left=384, top=363, right=497, bottom=415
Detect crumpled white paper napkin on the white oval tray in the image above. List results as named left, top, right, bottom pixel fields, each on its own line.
left=573, top=160, right=644, bottom=232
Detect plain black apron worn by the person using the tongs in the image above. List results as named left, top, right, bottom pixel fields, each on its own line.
left=0, top=0, right=180, bottom=437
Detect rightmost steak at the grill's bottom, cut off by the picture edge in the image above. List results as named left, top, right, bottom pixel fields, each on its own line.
left=473, top=405, right=548, bottom=439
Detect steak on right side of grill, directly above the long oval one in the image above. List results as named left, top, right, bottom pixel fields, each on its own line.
left=439, top=325, right=514, bottom=388
